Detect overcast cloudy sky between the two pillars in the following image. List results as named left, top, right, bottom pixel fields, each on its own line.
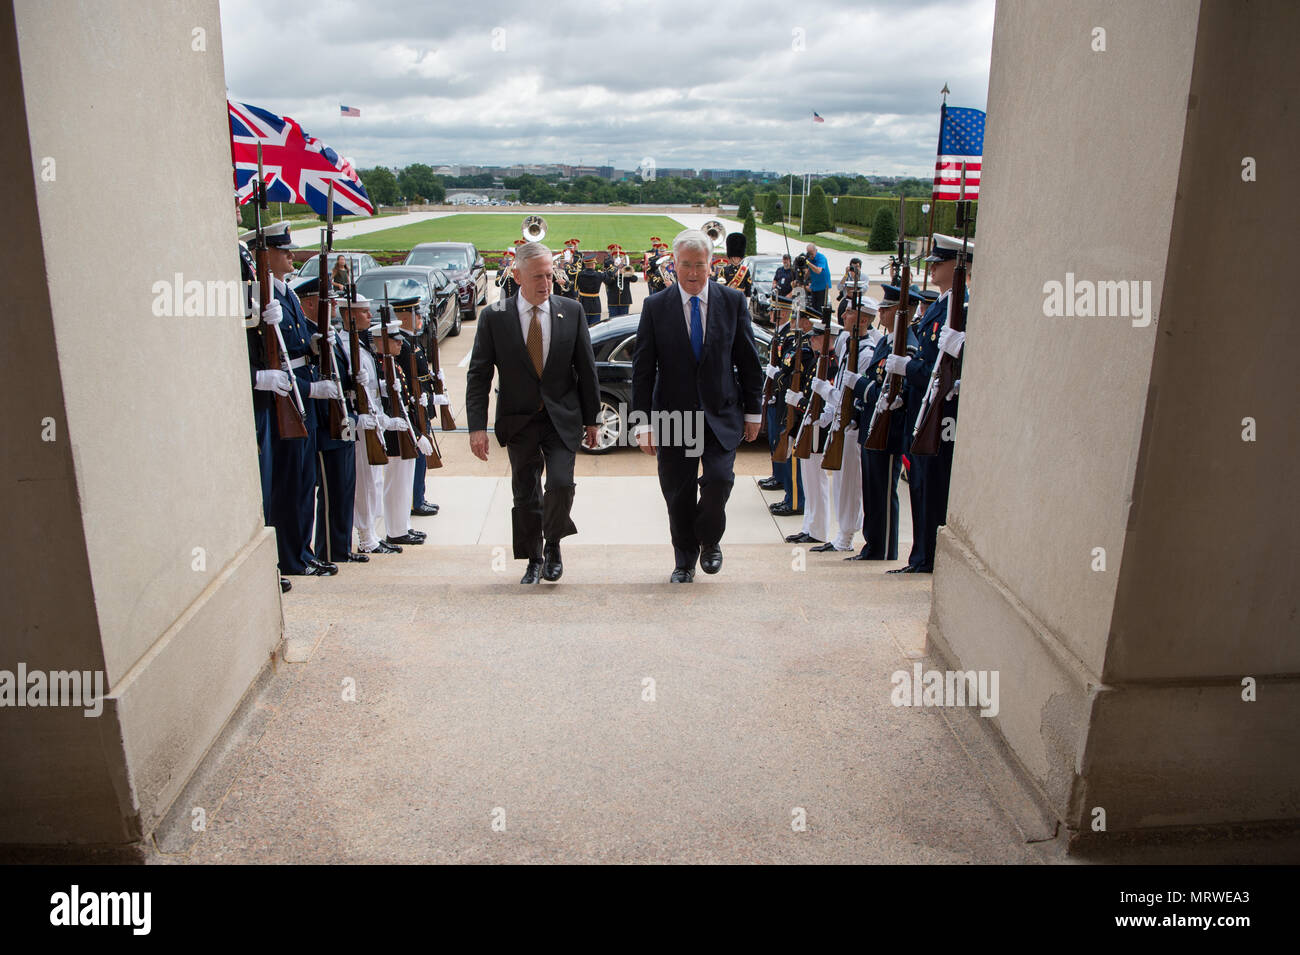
left=221, top=0, right=993, bottom=177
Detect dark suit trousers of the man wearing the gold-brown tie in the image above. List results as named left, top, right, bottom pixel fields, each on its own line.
left=506, top=408, right=577, bottom=560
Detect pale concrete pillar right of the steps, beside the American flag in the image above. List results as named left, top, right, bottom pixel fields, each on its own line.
left=930, top=0, right=1300, bottom=845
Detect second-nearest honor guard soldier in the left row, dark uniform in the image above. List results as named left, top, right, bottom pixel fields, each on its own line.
left=293, top=277, right=369, bottom=564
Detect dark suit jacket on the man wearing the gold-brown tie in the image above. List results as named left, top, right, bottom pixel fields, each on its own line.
left=465, top=295, right=601, bottom=451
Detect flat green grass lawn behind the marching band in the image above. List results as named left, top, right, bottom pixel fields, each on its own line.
left=334, top=212, right=681, bottom=252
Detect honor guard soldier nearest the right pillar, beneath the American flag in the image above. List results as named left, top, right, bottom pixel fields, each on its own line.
left=885, top=233, right=975, bottom=573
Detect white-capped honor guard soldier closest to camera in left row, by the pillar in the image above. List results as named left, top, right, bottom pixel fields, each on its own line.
left=239, top=222, right=338, bottom=577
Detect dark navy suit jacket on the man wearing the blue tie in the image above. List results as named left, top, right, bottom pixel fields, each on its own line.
left=632, top=282, right=763, bottom=451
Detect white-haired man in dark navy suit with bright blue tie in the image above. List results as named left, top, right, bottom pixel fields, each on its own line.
left=632, top=229, right=763, bottom=583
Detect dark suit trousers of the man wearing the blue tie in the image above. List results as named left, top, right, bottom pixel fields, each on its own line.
left=657, top=424, right=736, bottom=568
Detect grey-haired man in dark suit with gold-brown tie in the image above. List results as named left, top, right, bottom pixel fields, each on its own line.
left=465, top=242, right=601, bottom=583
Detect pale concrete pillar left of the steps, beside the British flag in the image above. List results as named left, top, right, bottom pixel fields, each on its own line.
left=0, top=0, right=281, bottom=846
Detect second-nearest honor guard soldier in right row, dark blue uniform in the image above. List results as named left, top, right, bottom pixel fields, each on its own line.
left=845, top=285, right=920, bottom=560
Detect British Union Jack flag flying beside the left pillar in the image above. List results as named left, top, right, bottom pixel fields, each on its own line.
left=226, top=100, right=374, bottom=216
